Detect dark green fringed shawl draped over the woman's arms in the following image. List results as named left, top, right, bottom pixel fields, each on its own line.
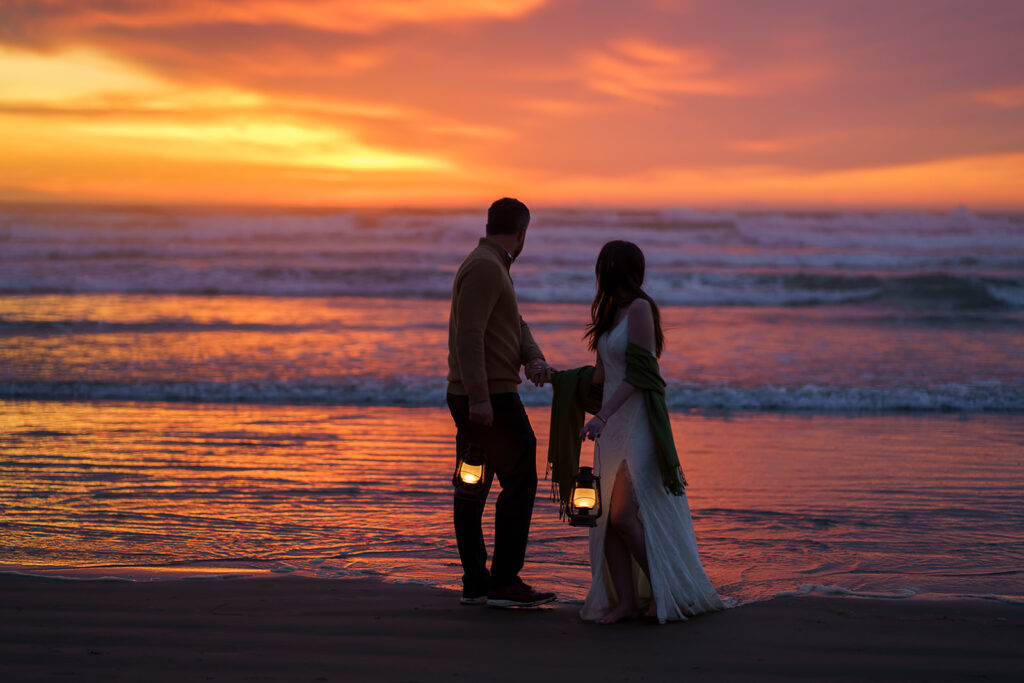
left=548, top=344, right=686, bottom=511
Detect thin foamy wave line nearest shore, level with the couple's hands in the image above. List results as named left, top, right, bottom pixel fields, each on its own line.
left=0, top=377, right=1024, bottom=414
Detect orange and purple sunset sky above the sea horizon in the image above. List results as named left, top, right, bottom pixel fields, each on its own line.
left=0, top=0, right=1024, bottom=211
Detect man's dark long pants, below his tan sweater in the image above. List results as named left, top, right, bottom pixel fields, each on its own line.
left=447, top=392, right=537, bottom=596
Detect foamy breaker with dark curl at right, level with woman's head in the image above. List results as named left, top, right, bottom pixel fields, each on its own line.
left=0, top=264, right=1024, bottom=310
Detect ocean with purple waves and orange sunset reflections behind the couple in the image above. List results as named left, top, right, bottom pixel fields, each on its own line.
left=0, top=206, right=1024, bottom=602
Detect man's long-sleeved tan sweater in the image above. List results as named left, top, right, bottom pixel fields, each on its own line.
left=447, top=238, right=544, bottom=403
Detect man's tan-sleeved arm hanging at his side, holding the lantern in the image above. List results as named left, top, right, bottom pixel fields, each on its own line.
left=453, top=261, right=501, bottom=417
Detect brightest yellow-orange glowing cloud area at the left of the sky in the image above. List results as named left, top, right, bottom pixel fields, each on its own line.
left=0, top=43, right=457, bottom=201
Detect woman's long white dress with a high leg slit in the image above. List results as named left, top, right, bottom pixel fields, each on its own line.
left=580, top=317, right=725, bottom=624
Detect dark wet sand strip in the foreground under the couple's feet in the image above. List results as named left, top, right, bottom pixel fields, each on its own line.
left=0, top=577, right=1024, bottom=683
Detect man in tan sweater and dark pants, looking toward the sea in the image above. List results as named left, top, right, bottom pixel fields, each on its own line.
left=447, top=198, right=555, bottom=607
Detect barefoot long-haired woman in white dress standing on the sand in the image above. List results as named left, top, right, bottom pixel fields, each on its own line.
left=580, top=241, right=724, bottom=624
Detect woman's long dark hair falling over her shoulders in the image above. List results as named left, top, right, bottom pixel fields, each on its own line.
left=583, top=240, right=665, bottom=357
